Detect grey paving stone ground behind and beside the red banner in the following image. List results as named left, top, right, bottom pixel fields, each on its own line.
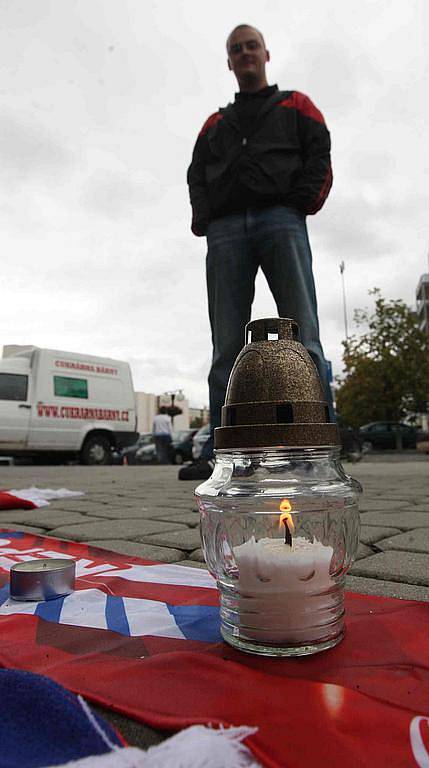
left=0, top=456, right=429, bottom=747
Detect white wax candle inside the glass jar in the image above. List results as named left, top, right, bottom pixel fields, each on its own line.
left=234, top=536, right=338, bottom=644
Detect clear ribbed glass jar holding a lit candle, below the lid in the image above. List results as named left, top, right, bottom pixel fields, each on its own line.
left=196, top=447, right=361, bottom=656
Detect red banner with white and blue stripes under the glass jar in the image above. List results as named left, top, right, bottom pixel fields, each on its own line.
left=0, top=531, right=429, bottom=768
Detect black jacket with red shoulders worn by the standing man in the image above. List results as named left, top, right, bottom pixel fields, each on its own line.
left=188, top=90, right=332, bottom=235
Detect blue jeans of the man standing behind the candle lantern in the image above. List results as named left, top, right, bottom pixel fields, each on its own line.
left=202, top=205, right=335, bottom=458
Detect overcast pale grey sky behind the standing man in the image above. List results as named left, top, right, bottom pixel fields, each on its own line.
left=0, top=0, right=429, bottom=406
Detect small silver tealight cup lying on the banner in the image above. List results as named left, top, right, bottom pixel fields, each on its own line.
left=10, top=557, right=76, bottom=601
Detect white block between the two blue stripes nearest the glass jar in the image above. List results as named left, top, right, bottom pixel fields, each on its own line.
left=122, top=597, right=185, bottom=640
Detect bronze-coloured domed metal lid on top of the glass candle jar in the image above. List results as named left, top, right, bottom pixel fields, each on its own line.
left=214, top=317, right=340, bottom=450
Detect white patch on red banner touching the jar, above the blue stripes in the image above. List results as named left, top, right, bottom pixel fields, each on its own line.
left=109, top=565, right=216, bottom=589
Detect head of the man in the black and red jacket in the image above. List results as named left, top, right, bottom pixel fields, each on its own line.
left=228, top=27, right=270, bottom=82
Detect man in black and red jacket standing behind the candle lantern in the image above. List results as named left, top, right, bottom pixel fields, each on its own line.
left=179, top=24, right=334, bottom=480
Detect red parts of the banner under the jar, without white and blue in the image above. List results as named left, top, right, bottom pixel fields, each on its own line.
left=0, top=533, right=429, bottom=768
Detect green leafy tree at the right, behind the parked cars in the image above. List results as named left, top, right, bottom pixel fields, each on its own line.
left=336, top=288, right=429, bottom=427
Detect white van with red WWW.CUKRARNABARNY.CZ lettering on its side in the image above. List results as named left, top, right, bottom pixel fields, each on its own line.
left=0, top=346, right=138, bottom=464
